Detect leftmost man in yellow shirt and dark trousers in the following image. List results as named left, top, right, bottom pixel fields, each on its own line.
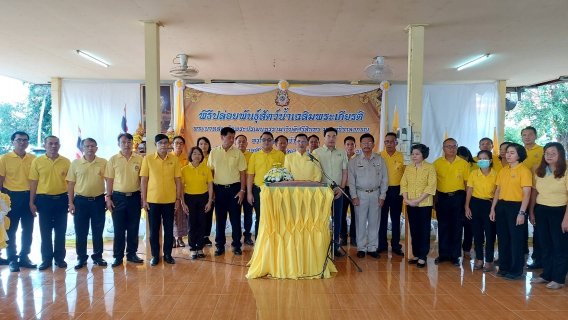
left=0, top=131, right=37, bottom=272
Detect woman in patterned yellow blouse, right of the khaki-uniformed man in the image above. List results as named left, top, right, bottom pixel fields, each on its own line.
left=400, top=144, right=437, bottom=268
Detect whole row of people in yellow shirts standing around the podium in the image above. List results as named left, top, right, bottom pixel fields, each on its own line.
left=0, top=127, right=568, bottom=289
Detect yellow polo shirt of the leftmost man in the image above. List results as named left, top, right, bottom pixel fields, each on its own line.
left=0, top=151, right=36, bottom=191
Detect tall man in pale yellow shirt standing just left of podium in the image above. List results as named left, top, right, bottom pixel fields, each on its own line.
left=207, top=127, right=245, bottom=256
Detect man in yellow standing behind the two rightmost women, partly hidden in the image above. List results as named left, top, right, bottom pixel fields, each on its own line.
left=521, top=126, right=544, bottom=270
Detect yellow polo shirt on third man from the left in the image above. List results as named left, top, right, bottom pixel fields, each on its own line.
left=65, top=156, right=107, bottom=197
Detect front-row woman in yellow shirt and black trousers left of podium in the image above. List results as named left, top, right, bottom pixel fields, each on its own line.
left=181, top=147, right=213, bottom=260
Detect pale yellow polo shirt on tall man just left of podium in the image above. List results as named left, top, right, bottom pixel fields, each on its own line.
left=207, top=146, right=247, bottom=185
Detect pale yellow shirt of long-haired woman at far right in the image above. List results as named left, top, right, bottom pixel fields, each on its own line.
left=533, top=170, right=568, bottom=207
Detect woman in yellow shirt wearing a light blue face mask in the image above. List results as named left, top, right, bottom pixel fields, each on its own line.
left=465, top=150, right=497, bottom=272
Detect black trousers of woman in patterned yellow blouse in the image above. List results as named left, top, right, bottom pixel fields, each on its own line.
left=406, top=206, right=432, bottom=260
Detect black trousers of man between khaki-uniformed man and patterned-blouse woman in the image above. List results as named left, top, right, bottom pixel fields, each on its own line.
left=379, top=186, right=402, bottom=251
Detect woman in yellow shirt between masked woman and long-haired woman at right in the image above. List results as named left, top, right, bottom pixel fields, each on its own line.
left=489, top=143, right=532, bottom=280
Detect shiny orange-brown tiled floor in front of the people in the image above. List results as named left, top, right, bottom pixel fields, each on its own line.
left=0, top=241, right=568, bottom=320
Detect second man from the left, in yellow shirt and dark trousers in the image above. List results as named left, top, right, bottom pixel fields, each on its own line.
left=29, top=136, right=71, bottom=270
